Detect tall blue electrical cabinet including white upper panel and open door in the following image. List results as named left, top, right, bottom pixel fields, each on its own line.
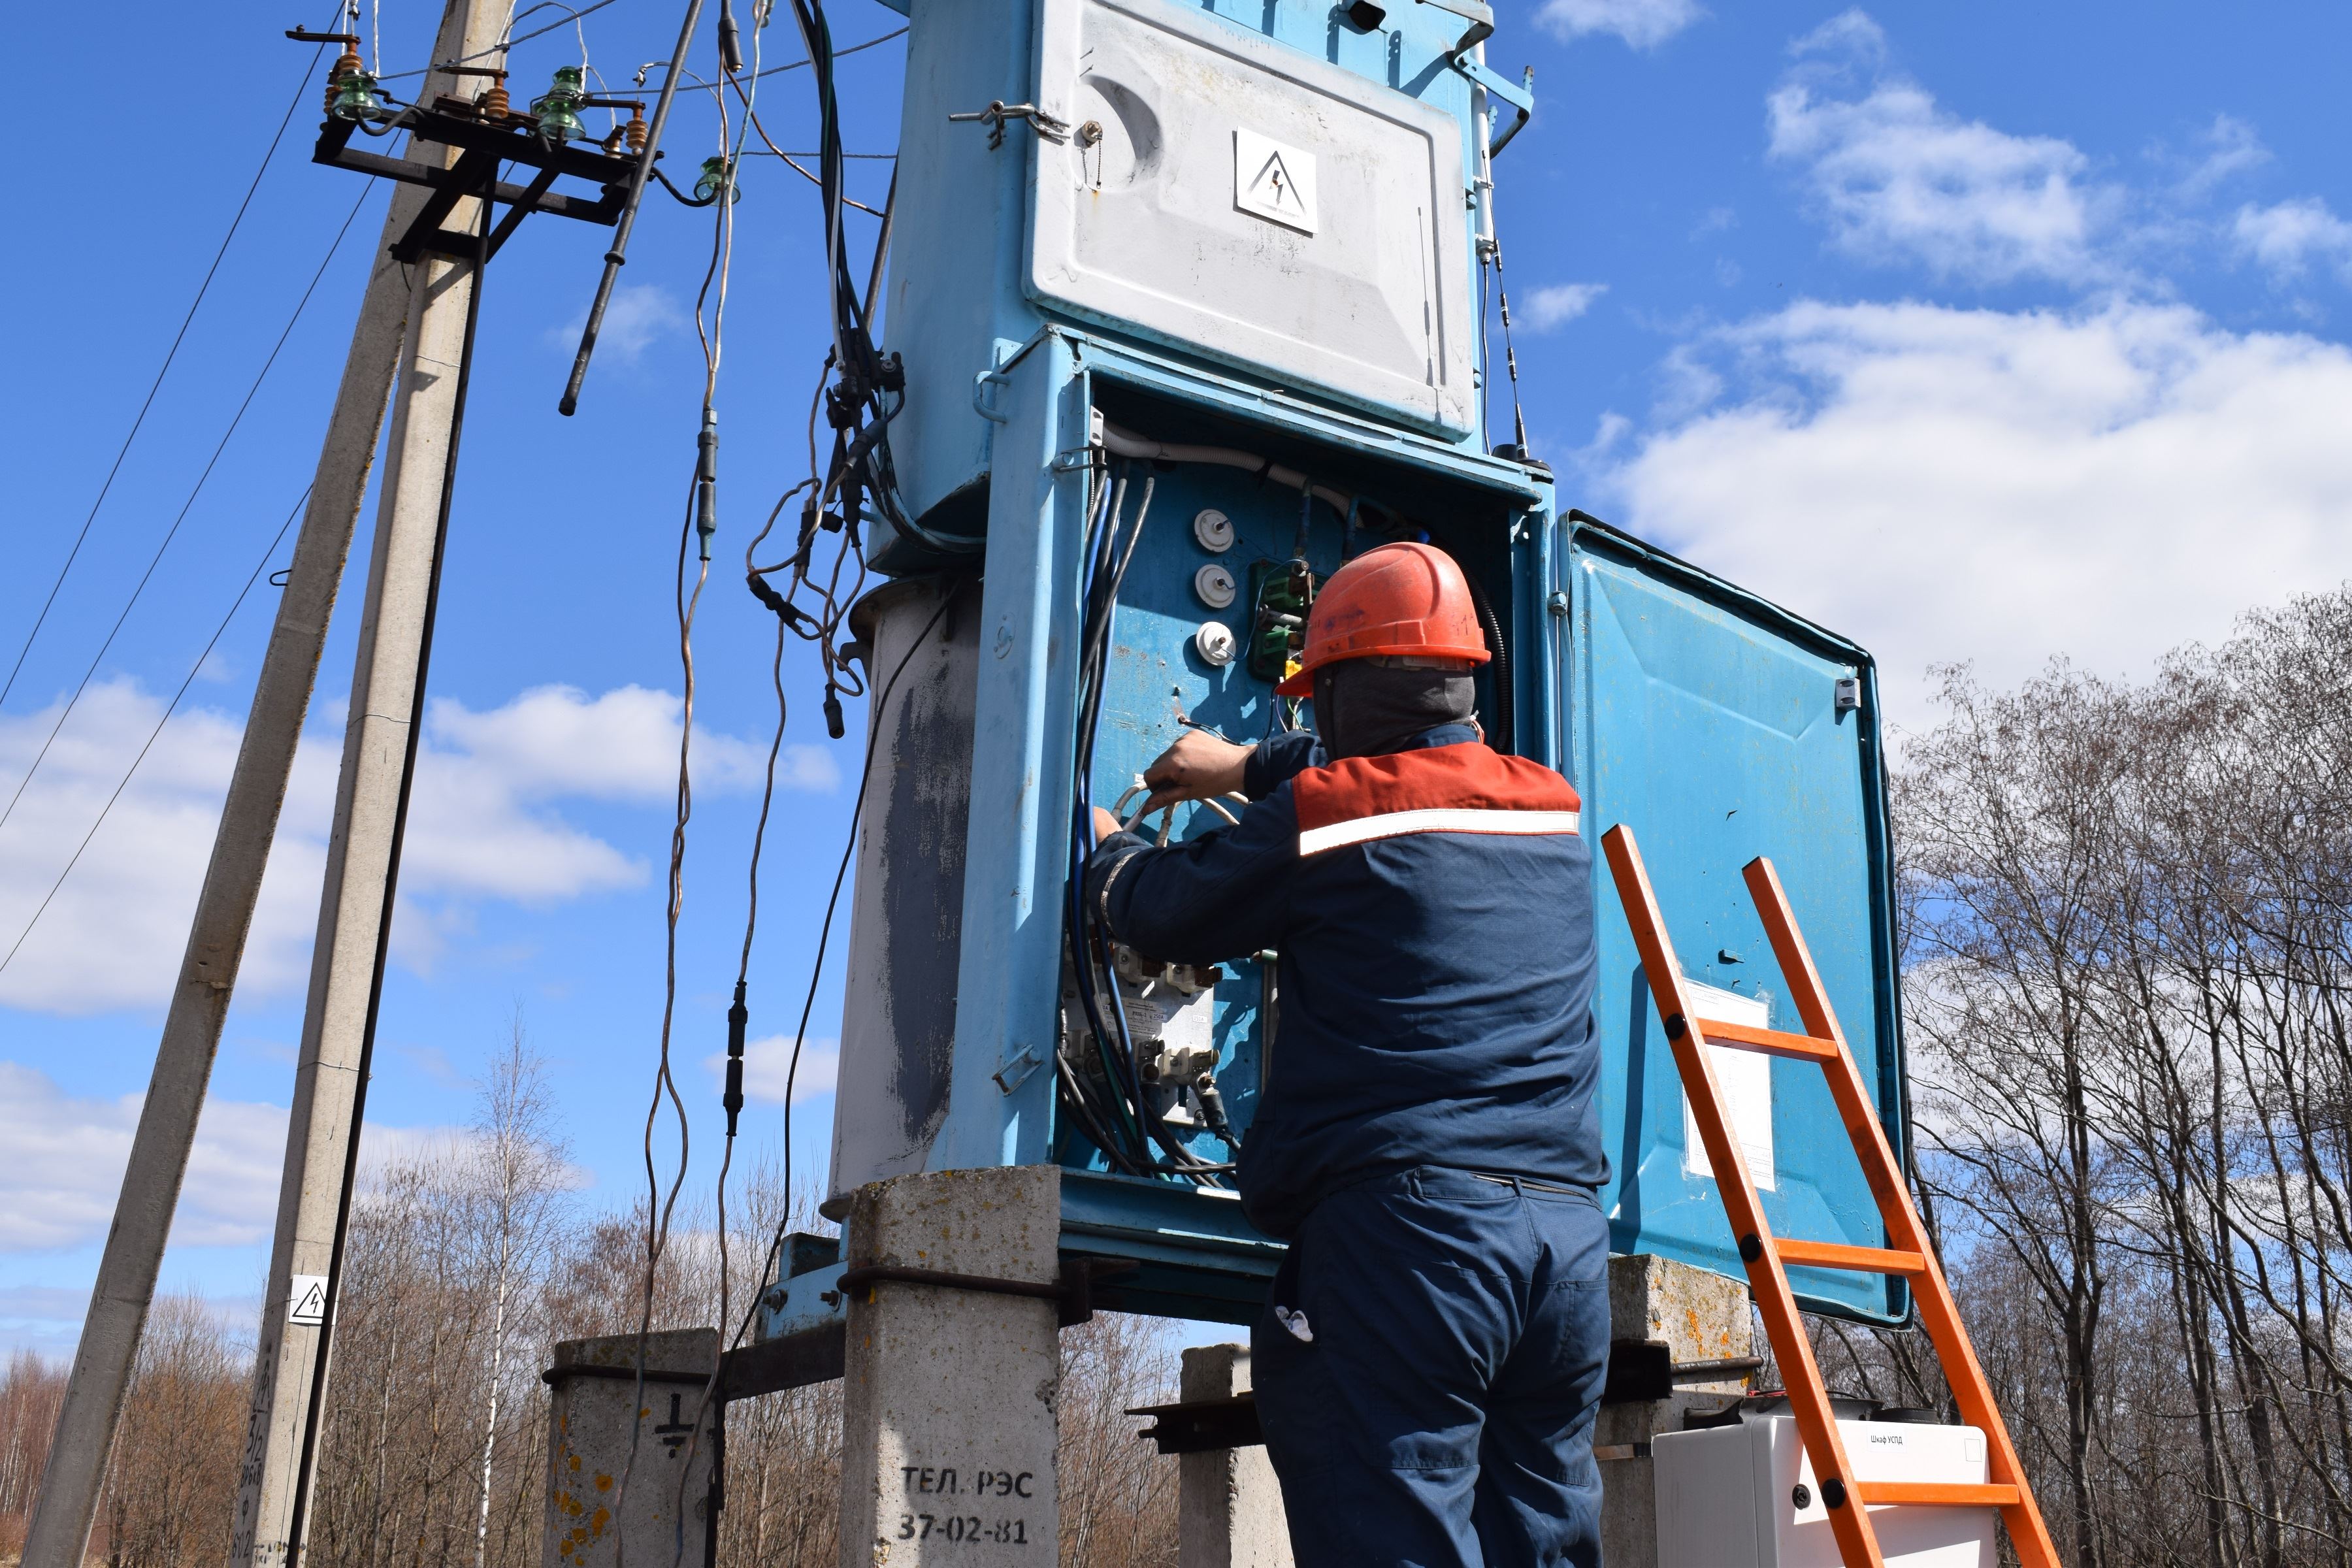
left=764, top=0, right=1908, bottom=1335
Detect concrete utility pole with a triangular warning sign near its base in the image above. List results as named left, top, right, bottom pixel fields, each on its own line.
left=231, top=0, right=510, bottom=1568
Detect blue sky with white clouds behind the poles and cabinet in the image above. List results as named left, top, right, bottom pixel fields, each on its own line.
left=0, top=0, right=2352, bottom=1354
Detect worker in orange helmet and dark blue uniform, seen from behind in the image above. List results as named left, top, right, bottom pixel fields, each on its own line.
left=1085, top=543, right=1609, bottom=1568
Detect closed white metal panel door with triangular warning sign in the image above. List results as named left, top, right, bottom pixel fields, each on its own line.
left=1014, top=0, right=1475, bottom=435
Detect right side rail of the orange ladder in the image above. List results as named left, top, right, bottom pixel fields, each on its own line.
left=1740, top=856, right=2058, bottom=1568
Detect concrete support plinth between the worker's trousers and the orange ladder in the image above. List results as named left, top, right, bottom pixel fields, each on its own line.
left=1592, top=1253, right=1755, bottom=1568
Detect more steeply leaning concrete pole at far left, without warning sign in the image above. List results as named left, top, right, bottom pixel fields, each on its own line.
left=24, top=24, right=487, bottom=1568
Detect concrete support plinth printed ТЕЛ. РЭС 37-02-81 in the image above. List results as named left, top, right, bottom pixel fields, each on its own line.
left=842, top=1166, right=1061, bottom=1568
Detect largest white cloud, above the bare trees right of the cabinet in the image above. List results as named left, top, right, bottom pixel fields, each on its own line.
left=1588, top=303, right=2352, bottom=722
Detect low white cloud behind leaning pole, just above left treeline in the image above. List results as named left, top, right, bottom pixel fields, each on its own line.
left=0, top=1060, right=287, bottom=1253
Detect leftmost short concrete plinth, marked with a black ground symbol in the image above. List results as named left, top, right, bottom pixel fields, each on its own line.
left=538, top=1328, right=720, bottom=1568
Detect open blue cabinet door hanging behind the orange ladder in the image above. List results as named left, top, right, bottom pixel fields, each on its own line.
left=1550, top=512, right=1910, bottom=1324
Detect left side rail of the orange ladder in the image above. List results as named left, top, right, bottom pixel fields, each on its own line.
left=1602, top=823, right=1886, bottom=1568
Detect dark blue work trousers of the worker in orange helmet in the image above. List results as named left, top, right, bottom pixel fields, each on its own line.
left=1251, top=1166, right=1609, bottom=1568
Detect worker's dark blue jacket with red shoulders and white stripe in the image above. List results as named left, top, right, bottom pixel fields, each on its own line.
left=1086, top=724, right=1609, bottom=1237
